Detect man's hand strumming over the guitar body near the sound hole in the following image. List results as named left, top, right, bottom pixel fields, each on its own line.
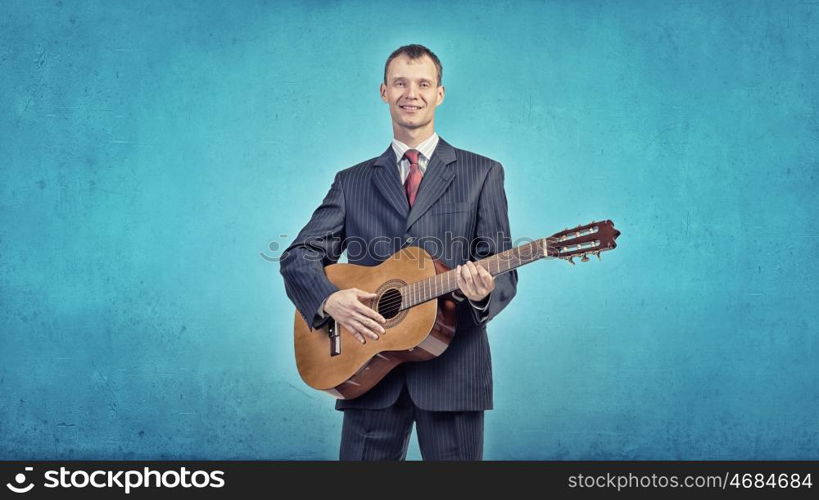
left=324, top=288, right=387, bottom=344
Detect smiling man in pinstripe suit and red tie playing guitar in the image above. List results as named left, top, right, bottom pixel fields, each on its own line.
left=281, top=45, right=517, bottom=460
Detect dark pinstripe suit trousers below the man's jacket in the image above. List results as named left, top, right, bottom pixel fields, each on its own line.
left=339, top=386, right=483, bottom=461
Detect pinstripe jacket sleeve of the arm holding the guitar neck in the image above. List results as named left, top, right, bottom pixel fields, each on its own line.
left=470, top=163, right=518, bottom=324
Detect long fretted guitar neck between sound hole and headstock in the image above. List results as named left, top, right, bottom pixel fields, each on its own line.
left=400, top=238, right=546, bottom=309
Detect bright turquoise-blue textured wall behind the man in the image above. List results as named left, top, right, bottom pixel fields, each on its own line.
left=0, top=0, right=819, bottom=459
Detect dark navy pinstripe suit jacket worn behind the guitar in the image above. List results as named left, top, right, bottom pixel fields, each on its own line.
left=280, top=139, right=518, bottom=411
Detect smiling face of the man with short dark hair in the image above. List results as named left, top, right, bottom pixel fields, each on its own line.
left=381, top=54, right=444, bottom=129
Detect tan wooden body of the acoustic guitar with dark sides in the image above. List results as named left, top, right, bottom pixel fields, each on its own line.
left=294, top=247, right=457, bottom=399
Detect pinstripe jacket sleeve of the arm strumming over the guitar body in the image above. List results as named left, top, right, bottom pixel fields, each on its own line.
left=279, top=170, right=345, bottom=329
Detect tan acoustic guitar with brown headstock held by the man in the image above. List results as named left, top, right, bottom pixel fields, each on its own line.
left=295, top=220, right=620, bottom=399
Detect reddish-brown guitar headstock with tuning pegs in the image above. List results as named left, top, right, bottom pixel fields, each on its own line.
left=542, top=220, right=620, bottom=264
